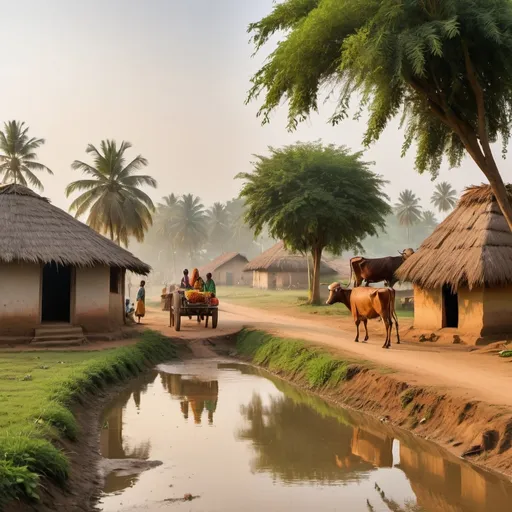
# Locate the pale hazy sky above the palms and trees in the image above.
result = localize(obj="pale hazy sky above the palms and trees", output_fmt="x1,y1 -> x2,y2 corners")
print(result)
0,0 -> 504,214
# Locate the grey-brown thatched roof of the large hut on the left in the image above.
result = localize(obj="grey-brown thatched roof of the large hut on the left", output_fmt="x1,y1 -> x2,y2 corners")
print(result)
0,185 -> 151,275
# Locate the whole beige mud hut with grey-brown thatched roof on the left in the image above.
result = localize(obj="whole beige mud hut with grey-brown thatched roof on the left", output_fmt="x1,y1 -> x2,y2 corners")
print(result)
0,185 -> 151,342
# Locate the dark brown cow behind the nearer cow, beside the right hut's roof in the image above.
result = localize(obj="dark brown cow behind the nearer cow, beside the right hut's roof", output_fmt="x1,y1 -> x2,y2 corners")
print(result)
350,249 -> 414,288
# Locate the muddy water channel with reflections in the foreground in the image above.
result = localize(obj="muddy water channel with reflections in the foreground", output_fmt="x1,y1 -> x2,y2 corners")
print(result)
100,361 -> 512,512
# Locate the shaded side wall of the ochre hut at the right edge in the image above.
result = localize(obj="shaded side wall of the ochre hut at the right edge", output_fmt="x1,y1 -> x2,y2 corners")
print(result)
482,286 -> 512,336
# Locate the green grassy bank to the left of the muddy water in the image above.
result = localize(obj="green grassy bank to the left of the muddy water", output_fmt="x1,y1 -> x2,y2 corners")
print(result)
0,331 -> 175,508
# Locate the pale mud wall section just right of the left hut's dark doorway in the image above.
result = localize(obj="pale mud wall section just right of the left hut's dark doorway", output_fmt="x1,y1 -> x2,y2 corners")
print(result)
73,266 -> 110,332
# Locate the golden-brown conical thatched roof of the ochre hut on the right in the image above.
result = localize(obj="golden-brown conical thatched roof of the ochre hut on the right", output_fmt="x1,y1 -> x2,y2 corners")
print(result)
397,185 -> 512,290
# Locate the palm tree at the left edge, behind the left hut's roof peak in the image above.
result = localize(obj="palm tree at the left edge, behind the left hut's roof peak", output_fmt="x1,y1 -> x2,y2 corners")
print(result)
0,121 -> 53,190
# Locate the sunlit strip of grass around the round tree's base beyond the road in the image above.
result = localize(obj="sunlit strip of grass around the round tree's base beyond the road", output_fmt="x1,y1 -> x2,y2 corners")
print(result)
217,286 -> 414,318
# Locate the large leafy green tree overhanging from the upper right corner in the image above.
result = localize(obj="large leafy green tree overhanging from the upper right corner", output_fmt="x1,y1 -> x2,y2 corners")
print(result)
248,0 -> 512,229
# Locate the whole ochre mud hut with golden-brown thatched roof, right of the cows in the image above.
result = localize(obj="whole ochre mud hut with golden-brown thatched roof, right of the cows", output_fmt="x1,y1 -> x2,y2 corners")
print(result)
397,185 -> 512,342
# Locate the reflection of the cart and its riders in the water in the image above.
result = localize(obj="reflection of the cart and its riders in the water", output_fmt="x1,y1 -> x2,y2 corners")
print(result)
160,373 -> 219,425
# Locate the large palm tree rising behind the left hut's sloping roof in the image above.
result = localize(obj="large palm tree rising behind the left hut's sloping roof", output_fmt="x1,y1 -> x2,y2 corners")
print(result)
66,140 -> 157,247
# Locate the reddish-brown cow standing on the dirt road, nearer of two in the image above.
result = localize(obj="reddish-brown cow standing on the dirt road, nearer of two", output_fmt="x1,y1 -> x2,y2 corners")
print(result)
327,283 -> 400,348
